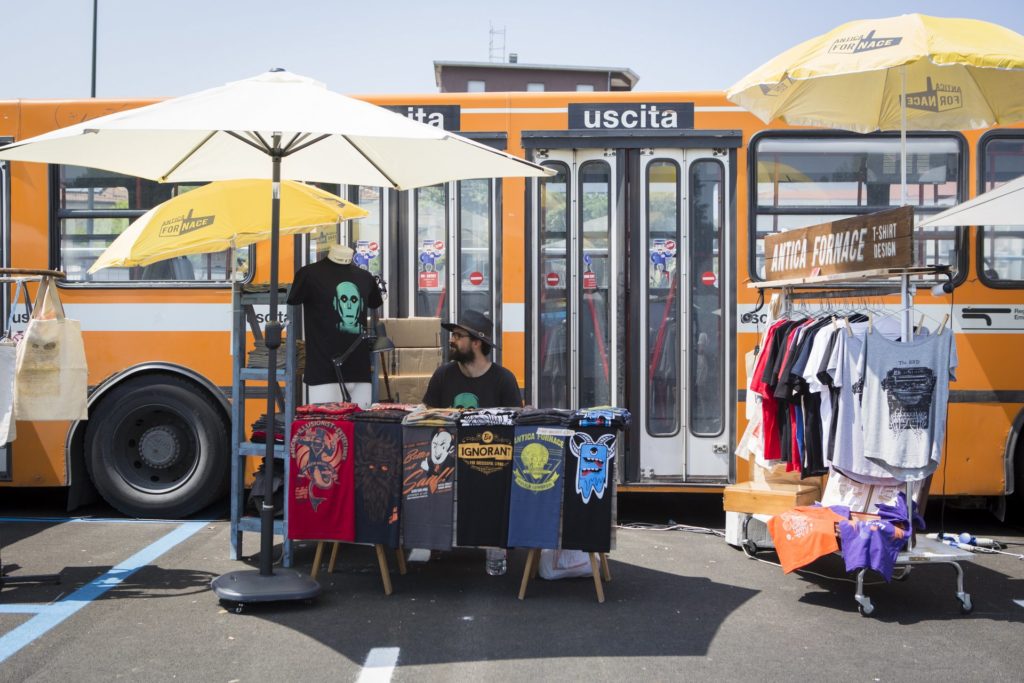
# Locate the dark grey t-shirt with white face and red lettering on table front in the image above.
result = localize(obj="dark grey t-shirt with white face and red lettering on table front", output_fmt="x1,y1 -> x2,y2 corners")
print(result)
401,425 -> 456,550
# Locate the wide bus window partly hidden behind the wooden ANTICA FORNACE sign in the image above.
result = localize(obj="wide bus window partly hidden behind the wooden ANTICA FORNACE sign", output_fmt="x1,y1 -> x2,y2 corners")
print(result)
750,134 -> 965,279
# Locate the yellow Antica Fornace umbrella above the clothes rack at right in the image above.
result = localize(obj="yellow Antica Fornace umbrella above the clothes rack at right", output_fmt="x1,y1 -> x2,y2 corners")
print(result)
726,14 -> 1024,204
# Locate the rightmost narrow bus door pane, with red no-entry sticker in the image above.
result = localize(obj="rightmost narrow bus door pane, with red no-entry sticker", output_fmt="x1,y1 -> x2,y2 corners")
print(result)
688,160 -> 725,436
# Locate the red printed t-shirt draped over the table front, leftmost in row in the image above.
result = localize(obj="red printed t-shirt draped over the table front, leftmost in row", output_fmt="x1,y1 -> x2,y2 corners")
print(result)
288,415 -> 355,542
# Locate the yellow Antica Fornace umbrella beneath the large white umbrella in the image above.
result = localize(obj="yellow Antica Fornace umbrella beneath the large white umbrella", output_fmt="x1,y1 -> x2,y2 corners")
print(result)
89,179 -> 369,273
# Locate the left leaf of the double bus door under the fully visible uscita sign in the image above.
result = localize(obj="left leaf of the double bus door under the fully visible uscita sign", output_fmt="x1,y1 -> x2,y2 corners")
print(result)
527,150 -> 625,408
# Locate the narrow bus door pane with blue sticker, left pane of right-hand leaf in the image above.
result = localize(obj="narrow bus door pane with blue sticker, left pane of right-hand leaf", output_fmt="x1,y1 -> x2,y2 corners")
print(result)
646,161 -> 683,436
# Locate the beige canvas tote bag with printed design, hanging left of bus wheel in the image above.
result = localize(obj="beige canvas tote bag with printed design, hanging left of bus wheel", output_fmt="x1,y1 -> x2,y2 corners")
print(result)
14,278 -> 89,420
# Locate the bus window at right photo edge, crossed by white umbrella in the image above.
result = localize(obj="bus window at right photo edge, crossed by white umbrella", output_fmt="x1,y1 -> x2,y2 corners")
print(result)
978,131 -> 1024,288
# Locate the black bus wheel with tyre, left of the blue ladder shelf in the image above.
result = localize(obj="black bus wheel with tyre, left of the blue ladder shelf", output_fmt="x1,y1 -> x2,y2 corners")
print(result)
85,375 -> 229,518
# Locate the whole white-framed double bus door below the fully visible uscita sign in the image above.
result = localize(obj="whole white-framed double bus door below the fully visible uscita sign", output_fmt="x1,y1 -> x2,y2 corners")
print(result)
527,144 -> 735,484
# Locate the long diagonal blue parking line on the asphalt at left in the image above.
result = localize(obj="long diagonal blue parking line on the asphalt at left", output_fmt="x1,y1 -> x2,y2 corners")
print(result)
0,521 -> 206,663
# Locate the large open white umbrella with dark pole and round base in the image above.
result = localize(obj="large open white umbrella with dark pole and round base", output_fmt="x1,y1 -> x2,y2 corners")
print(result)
0,69 -> 553,603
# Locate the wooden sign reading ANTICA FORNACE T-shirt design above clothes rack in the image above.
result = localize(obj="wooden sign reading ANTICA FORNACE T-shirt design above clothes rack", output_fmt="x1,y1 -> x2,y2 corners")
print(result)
765,206 -> 913,281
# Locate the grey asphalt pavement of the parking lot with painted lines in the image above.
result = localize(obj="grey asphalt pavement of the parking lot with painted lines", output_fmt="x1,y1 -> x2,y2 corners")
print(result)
0,492 -> 1024,682
